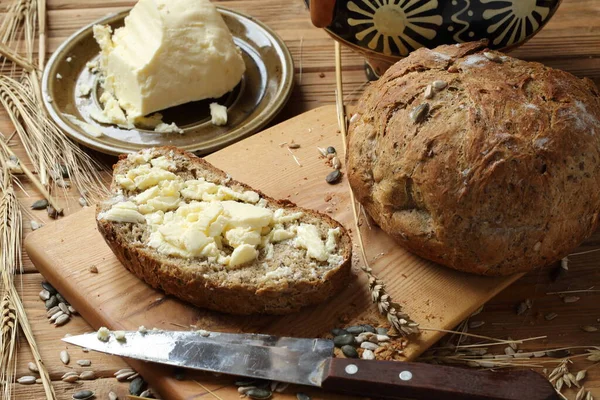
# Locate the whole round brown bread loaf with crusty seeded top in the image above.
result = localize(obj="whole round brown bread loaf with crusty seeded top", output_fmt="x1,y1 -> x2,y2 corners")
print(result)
347,42 -> 600,275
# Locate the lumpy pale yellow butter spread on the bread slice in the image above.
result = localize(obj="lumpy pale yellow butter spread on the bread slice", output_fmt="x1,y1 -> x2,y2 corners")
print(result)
98,152 -> 344,268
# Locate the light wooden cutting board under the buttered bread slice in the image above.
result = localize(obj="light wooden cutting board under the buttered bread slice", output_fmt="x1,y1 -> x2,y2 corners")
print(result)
25,106 -> 519,400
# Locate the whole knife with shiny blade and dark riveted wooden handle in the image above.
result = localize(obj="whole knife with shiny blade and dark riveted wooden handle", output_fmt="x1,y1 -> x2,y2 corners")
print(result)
62,330 -> 559,400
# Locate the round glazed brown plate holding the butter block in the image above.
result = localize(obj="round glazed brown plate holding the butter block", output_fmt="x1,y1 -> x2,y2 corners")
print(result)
42,7 -> 294,154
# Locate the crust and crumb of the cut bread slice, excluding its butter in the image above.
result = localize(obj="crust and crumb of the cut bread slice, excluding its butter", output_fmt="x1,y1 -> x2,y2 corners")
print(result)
96,147 -> 352,314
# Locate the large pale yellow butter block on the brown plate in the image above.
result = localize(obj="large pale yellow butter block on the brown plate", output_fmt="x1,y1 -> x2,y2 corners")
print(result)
94,0 -> 245,120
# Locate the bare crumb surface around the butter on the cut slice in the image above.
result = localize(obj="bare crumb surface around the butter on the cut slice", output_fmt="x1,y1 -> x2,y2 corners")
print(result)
98,148 -> 350,288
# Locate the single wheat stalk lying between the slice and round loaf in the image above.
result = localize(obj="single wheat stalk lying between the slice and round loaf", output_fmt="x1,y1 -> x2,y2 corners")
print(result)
335,41 -> 419,336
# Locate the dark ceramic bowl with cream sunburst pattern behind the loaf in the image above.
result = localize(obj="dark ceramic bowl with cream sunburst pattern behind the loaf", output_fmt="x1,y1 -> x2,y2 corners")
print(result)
305,0 -> 561,75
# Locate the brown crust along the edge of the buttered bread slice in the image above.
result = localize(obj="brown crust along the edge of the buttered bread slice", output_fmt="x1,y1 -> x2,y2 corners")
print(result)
96,147 -> 352,315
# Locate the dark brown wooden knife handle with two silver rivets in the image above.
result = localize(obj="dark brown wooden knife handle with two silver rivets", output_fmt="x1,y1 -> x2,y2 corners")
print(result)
321,358 -> 559,400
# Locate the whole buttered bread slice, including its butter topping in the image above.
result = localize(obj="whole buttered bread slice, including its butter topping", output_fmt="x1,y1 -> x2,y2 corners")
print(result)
97,147 -> 352,314
